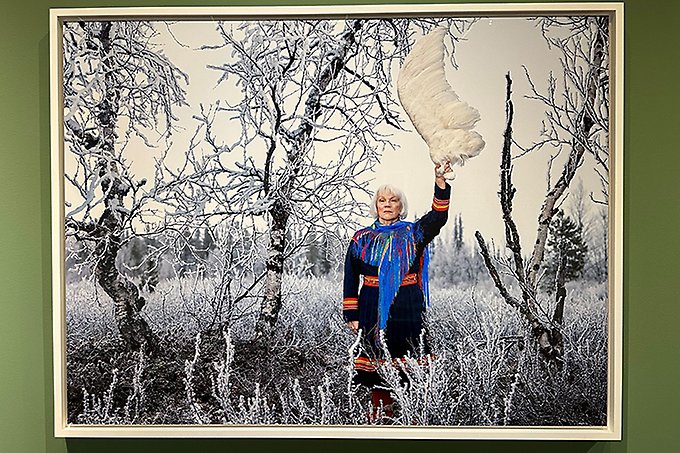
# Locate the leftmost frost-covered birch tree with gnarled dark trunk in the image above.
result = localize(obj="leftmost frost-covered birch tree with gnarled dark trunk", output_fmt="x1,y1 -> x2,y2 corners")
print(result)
63,21 -> 187,349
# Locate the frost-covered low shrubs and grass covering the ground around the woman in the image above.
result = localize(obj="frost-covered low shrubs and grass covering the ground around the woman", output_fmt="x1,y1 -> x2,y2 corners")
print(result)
68,274 -> 607,426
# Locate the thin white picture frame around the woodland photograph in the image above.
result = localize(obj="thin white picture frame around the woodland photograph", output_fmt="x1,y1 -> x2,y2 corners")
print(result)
50,3 -> 624,441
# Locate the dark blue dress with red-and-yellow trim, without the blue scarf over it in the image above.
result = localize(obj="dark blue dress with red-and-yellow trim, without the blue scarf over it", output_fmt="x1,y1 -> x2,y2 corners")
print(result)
343,184 -> 451,387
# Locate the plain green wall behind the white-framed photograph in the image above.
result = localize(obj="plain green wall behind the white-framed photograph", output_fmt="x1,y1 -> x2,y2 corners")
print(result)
0,0 -> 680,453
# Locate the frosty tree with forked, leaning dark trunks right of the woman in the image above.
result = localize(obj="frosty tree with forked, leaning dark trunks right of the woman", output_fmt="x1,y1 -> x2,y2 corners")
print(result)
475,16 -> 609,363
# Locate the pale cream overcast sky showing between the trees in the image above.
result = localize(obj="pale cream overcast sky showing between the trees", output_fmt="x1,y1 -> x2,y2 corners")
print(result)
65,18 -> 599,249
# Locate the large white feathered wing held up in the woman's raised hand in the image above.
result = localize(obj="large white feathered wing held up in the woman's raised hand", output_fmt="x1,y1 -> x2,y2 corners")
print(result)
397,27 -> 485,179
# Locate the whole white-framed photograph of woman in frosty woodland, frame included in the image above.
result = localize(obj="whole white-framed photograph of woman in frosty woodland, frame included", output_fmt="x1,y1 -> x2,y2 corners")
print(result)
50,3 -> 623,440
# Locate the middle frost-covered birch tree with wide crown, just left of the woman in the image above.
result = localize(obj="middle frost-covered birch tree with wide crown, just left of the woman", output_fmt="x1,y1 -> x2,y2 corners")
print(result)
196,18 -> 471,338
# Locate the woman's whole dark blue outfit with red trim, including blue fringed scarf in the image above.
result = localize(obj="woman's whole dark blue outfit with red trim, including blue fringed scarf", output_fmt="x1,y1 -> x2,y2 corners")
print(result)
343,184 -> 451,387
